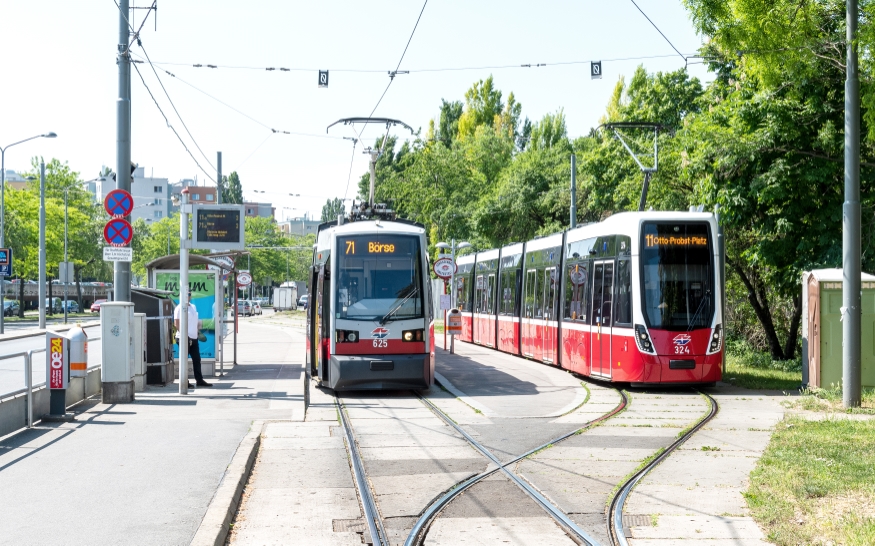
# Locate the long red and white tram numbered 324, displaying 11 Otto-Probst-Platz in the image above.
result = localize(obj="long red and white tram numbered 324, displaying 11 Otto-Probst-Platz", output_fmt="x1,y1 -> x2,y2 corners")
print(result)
455,212 -> 723,384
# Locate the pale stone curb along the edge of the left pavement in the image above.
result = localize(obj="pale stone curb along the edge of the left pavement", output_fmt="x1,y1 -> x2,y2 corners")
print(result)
191,420 -> 265,546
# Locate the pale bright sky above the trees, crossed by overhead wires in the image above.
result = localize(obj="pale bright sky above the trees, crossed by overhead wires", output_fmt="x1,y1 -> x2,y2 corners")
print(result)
0,0 -> 711,220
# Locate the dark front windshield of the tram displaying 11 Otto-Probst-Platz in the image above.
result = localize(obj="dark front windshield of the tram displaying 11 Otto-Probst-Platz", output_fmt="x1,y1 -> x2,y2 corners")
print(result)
641,222 -> 714,331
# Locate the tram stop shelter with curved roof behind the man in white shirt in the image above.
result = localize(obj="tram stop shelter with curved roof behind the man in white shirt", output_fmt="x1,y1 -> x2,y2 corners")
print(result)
146,254 -> 237,377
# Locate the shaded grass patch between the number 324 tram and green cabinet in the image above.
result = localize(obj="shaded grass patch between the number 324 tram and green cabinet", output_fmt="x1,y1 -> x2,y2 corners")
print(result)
723,339 -> 802,391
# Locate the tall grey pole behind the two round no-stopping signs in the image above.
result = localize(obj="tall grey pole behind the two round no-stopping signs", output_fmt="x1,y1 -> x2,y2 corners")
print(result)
113,0 -> 131,301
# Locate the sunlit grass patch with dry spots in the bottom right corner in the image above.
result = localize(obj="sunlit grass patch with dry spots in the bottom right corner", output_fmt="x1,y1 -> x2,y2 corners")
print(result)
745,418 -> 875,546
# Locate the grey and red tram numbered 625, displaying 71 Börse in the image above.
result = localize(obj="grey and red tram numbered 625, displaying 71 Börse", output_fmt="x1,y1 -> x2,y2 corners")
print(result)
307,220 -> 434,390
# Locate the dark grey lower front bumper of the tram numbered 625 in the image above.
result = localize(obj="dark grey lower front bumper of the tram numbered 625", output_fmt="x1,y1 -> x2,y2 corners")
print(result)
327,354 -> 434,391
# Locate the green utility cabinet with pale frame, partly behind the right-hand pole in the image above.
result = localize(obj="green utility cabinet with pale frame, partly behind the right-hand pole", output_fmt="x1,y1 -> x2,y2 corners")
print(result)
802,269 -> 875,387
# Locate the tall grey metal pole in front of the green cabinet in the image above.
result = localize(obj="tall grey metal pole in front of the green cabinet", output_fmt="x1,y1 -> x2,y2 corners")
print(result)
842,0 -> 861,408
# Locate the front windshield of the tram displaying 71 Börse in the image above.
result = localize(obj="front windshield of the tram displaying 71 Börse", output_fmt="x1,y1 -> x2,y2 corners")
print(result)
335,234 -> 424,322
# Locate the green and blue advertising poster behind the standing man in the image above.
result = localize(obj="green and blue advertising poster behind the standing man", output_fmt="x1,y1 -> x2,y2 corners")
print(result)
155,271 -> 221,360
